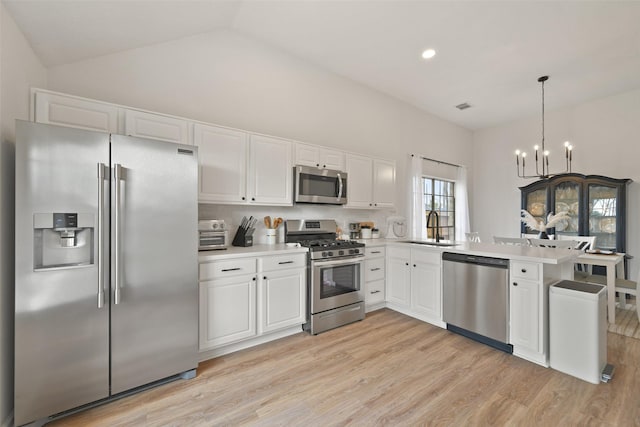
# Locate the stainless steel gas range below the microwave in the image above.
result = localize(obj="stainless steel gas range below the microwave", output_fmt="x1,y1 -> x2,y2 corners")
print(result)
285,220 -> 364,335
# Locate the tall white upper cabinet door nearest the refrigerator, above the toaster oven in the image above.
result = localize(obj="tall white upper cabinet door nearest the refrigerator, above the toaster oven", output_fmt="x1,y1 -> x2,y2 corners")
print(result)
193,124 -> 248,203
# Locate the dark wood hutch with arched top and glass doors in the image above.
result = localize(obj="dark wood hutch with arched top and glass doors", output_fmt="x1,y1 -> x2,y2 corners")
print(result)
520,173 -> 631,253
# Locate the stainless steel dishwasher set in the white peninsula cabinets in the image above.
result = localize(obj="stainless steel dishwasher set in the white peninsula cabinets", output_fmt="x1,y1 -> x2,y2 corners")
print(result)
442,252 -> 513,353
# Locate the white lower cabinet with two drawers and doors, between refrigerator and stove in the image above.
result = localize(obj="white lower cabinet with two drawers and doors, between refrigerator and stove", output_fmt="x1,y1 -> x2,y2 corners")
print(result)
199,253 -> 307,360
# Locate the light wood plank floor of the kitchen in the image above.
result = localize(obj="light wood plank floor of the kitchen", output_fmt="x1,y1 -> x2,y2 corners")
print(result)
51,309 -> 640,426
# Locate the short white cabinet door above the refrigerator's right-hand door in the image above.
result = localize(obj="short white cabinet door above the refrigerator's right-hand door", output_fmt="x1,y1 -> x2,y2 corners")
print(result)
124,110 -> 189,144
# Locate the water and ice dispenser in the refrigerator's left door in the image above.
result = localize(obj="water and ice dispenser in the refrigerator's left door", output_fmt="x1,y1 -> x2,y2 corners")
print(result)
33,213 -> 95,270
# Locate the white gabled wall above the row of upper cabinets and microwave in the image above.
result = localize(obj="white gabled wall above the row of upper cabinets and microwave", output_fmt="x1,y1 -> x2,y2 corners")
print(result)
48,31 -> 471,226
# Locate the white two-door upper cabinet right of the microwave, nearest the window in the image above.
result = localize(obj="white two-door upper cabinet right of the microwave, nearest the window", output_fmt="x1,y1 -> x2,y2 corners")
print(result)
346,154 -> 396,208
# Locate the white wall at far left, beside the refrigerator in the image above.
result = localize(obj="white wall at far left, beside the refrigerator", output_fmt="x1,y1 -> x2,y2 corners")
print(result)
0,5 -> 47,426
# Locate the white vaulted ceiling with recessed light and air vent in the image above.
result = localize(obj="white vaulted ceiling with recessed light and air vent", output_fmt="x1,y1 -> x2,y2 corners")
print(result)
3,0 -> 640,129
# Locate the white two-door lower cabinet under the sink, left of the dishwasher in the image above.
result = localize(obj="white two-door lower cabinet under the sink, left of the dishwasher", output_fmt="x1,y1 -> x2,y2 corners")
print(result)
387,246 -> 445,327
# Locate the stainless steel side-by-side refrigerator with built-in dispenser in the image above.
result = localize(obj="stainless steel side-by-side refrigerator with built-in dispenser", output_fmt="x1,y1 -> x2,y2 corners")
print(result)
14,121 -> 198,425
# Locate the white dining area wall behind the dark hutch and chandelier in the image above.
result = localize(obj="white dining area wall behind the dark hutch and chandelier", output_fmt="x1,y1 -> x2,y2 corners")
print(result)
472,90 -> 640,278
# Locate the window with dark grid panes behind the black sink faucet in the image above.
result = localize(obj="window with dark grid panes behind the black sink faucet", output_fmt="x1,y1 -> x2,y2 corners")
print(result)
423,177 -> 456,240
